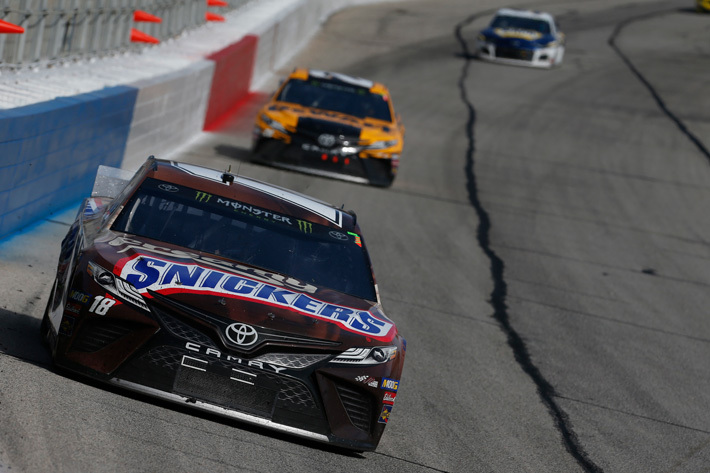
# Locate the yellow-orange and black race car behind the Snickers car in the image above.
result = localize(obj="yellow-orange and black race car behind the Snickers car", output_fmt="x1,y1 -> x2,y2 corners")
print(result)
252,69 -> 404,187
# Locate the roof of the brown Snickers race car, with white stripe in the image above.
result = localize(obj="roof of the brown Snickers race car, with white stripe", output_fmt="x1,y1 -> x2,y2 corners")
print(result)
146,158 -> 359,233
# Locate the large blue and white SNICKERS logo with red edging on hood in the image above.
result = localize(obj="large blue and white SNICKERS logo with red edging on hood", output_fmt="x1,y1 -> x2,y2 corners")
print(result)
115,251 -> 394,341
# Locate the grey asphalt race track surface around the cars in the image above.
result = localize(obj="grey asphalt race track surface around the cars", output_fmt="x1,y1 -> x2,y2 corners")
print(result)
0,0 -> 710,472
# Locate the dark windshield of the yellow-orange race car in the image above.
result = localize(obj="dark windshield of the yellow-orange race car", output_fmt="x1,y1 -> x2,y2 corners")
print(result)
276,79 -> 392,122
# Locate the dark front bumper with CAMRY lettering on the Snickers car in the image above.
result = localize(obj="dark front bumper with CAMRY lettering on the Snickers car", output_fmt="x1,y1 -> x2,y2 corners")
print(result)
53,292 -> 399,451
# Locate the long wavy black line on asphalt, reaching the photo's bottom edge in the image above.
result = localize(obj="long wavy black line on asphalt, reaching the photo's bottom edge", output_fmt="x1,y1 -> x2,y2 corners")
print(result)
455,9 -> 603,473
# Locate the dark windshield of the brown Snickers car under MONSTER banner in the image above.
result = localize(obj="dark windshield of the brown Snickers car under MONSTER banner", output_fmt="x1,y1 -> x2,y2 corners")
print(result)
112,178 -> 377,301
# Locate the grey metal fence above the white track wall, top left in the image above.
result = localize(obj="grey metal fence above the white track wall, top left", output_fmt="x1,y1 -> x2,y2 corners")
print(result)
0,0 -> 251,70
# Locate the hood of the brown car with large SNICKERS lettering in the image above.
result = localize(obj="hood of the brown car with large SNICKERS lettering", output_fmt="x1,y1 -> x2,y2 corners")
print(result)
86,231 -> 397,346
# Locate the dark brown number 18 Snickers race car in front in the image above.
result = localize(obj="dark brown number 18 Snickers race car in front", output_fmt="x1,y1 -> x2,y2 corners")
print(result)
41,157 -> 406,451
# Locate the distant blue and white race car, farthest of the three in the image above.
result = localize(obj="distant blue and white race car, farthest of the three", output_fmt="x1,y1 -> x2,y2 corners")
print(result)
475,8 -> 565,68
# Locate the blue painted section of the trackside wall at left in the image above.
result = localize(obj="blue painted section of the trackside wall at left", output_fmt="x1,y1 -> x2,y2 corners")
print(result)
0,86 -> 138,238
